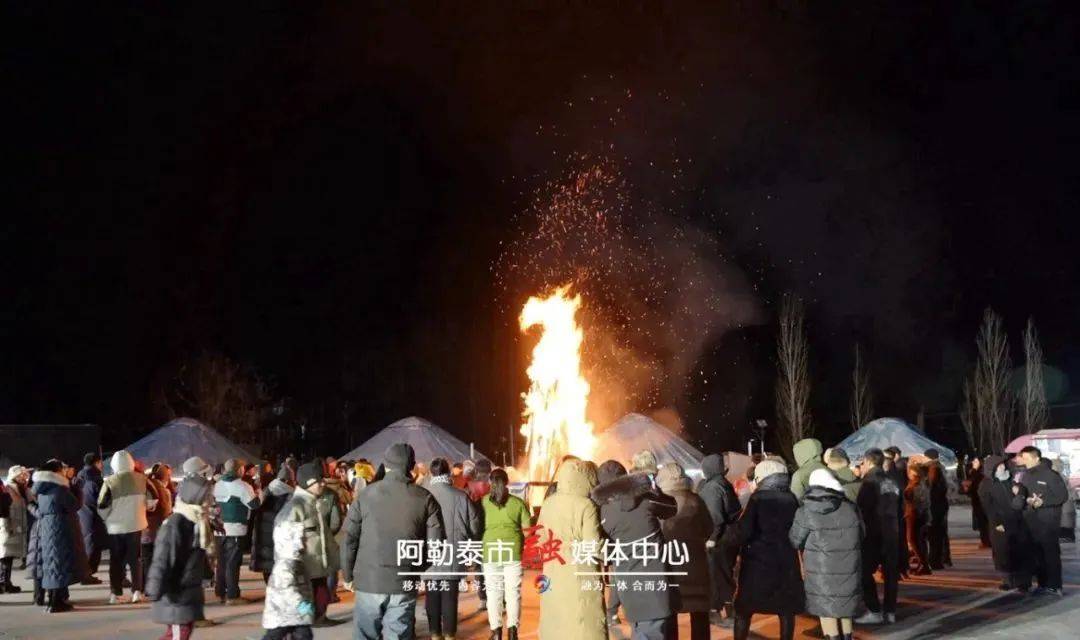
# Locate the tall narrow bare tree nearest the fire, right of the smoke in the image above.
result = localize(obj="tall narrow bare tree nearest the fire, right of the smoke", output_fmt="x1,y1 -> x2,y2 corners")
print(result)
777,294 -> 813,454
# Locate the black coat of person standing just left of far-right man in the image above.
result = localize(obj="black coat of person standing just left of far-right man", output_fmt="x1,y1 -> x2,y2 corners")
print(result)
978,459 -> 1030,573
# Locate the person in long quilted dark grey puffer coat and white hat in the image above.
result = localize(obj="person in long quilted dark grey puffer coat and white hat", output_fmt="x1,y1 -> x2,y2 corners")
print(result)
789,469 -> 863,640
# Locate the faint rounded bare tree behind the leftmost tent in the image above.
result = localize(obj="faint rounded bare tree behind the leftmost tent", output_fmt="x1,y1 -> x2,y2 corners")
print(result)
160,352 -> 271,442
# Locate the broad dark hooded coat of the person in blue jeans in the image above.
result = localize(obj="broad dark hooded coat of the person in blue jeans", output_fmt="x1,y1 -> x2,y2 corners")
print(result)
341,471 -> 445,594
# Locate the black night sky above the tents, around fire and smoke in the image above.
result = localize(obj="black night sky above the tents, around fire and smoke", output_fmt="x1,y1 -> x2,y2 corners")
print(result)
8,0 -> 1080,452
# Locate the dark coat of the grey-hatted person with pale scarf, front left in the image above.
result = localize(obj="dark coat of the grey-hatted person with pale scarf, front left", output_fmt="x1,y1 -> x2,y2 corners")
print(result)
146,513 -> 206,625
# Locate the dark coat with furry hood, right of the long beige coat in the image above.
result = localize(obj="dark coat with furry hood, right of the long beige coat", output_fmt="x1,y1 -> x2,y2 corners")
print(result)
592,463 -> 679,622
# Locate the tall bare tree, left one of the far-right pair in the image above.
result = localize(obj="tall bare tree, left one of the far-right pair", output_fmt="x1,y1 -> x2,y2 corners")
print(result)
971,309 -> 1013,453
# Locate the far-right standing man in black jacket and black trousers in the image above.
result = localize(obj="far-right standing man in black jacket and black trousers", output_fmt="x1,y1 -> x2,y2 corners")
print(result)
1016,447 -> 1068,596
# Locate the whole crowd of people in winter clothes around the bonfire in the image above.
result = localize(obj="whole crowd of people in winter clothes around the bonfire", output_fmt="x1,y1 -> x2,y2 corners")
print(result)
0,438 -> 1075,640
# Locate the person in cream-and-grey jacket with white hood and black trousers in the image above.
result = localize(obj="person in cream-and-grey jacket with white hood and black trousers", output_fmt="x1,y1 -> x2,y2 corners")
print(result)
97,451 -> 157,604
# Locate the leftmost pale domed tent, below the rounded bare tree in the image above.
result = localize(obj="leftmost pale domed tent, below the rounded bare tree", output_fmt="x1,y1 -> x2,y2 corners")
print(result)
120,418 -> 258,475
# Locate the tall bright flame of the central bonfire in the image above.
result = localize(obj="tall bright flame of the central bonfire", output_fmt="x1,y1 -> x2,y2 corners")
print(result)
519,286 -> 596,480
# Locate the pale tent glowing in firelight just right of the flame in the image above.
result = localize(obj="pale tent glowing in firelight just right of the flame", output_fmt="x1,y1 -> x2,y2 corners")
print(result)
593,413 -> 705,471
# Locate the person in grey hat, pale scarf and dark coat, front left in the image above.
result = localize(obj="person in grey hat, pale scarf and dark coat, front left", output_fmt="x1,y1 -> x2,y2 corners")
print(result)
146,474 -> 214,640
